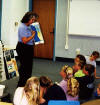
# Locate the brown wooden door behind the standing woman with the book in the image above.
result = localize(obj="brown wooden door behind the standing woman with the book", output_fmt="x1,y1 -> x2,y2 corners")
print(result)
32,0 -> 55,59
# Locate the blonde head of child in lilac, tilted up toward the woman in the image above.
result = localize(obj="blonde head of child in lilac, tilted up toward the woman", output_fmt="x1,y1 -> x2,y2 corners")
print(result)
60,65 -> 73,79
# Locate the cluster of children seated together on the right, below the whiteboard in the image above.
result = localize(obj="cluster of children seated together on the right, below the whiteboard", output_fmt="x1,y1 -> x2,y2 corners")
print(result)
59,51 -> 100,102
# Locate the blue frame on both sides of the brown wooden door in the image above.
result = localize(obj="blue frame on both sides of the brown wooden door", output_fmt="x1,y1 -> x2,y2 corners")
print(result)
29,0 -> 57,61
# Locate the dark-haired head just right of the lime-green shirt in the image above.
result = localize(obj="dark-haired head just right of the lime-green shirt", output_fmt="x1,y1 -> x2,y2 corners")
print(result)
83,64 -> 95,76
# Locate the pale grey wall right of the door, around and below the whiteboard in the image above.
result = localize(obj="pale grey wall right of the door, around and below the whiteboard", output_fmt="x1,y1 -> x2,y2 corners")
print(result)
55,0 -> 100,58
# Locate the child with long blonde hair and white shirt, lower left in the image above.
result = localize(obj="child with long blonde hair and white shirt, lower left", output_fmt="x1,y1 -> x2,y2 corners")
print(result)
13,77 -> 40,105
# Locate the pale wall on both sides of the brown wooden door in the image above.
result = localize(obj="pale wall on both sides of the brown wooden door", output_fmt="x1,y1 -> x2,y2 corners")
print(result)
1,0 -> 100,58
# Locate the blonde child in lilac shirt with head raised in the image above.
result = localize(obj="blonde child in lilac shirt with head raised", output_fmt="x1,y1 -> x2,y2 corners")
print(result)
59,65 -> 79,101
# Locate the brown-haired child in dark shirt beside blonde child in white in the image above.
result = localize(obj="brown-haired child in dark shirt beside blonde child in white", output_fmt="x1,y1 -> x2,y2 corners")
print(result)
39,76 -> 66,105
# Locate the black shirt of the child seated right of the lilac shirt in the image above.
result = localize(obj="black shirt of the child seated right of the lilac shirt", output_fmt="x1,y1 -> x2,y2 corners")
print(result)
75,76 -> 94,99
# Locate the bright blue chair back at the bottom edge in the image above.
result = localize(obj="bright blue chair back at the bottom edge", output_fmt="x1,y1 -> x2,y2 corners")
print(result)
48,100 -> 80,105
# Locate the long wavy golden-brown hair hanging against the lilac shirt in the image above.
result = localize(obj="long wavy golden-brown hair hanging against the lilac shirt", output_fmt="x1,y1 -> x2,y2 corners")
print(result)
67,77 -> 79,97
